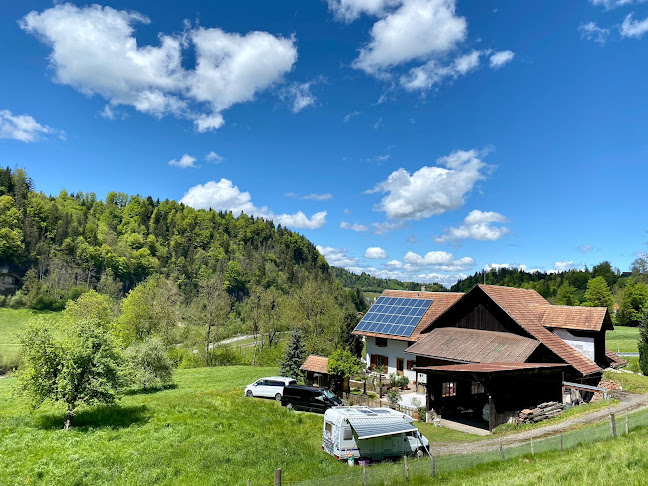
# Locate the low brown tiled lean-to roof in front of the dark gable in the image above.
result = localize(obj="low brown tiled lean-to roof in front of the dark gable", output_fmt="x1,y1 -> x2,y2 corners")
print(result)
405,327 -> 540,363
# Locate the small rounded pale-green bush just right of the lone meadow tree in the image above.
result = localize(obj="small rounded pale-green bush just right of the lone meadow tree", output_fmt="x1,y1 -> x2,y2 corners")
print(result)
124,338 -> 173,390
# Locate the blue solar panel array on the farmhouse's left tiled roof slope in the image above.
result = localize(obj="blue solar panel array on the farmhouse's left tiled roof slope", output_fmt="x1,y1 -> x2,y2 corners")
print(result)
355,297 -> 432,337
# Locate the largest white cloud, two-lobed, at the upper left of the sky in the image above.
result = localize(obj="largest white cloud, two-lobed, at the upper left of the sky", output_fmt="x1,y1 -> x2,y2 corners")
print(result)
20,3 -> 297,132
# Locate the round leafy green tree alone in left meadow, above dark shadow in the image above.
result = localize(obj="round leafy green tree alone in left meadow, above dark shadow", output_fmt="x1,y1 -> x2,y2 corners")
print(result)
18,320 -> 119,429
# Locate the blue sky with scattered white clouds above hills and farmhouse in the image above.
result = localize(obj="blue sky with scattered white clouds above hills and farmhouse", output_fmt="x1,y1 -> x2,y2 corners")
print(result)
0,0 -> 648,284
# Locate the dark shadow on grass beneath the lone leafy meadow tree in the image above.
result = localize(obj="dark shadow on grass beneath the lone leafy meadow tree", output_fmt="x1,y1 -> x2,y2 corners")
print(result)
36,405 -> 149,432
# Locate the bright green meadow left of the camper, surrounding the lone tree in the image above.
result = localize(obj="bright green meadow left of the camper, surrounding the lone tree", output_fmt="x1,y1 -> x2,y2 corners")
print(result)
0,367 -> 476,485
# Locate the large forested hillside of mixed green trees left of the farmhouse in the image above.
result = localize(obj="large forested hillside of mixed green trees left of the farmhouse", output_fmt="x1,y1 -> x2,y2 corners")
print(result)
0,168 -> 365,362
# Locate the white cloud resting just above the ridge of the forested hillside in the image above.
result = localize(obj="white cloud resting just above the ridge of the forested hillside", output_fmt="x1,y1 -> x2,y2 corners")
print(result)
180,178 -> 327,229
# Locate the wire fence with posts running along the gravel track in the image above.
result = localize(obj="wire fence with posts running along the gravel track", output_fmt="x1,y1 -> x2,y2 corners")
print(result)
248,411 -> 648,486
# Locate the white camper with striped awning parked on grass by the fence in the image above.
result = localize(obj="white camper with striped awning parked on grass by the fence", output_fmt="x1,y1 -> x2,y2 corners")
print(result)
322,407 -> 429,460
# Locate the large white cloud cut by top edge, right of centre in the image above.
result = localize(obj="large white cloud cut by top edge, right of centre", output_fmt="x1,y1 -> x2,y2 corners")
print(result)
353,0 -> 467,74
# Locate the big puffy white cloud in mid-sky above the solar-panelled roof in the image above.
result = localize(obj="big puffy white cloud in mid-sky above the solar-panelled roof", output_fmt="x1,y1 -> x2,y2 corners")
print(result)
367,150 -> 487,220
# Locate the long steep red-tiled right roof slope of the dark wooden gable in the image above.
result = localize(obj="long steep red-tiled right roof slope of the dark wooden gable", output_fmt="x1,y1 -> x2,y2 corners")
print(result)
478,285 -> 601,375
